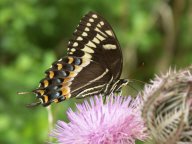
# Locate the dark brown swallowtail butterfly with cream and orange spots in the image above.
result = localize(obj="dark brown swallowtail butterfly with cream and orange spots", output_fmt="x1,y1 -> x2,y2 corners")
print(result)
24,12 -> 128,107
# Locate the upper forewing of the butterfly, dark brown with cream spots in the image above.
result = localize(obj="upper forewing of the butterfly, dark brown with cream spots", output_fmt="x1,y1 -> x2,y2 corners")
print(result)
68,12 -> 123,79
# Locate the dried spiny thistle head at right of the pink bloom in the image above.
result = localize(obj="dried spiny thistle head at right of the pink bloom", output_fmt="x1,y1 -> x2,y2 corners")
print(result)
140,65 -> 192,144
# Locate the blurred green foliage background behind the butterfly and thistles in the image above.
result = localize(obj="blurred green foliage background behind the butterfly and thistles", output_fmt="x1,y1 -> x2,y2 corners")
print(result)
0,0 -> 192,144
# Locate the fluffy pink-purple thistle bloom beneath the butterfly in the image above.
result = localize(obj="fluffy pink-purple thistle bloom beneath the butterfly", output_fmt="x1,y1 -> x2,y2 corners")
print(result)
51,96 -> 147,144
